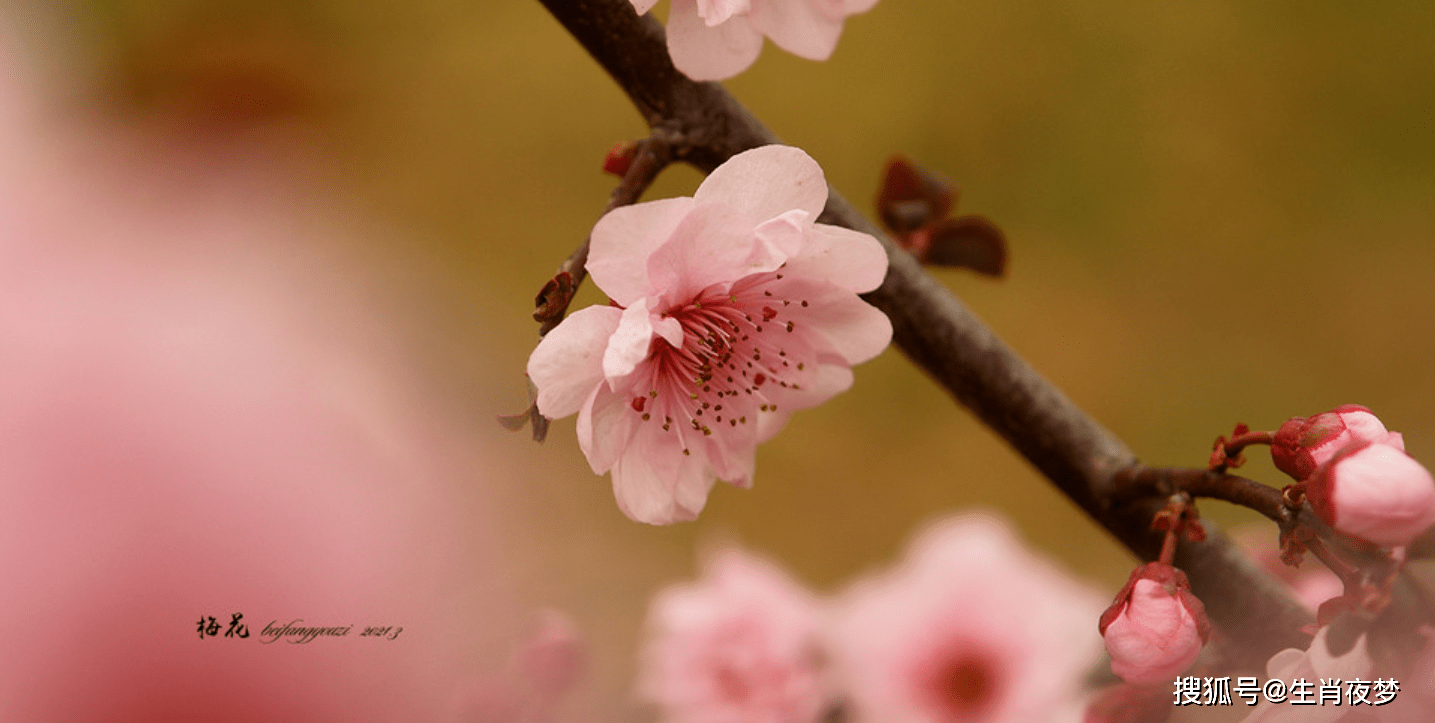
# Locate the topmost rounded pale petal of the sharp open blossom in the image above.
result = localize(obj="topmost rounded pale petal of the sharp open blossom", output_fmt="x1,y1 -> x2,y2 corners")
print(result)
693,145 -> 827,228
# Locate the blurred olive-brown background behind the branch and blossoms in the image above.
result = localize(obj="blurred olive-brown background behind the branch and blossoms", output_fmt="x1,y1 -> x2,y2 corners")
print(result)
0,0 -> 1435,720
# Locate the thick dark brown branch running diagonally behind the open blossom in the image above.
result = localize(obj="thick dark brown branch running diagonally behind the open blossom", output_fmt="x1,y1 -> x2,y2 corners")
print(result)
541,0 -> 1312,667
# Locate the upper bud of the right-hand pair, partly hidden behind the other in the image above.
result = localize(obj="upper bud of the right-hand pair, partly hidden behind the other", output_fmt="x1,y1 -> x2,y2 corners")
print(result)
1270,405 -> 1405,481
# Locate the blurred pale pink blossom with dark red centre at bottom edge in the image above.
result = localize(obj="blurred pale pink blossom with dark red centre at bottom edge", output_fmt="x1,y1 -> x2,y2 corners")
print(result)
832,515 -> 1102,723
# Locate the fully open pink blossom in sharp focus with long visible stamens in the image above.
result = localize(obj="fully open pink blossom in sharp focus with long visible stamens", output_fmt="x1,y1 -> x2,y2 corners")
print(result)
528,146 -> 891,524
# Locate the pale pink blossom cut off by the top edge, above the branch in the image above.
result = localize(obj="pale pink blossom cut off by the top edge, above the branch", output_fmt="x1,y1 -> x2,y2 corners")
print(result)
633,0 -> 877,80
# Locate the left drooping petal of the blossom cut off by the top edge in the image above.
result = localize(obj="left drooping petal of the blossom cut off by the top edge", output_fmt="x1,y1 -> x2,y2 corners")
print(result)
667,0 -> 762,80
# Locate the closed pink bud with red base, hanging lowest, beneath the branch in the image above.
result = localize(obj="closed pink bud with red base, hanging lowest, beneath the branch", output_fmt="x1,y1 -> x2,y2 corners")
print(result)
1101,562 -> 1211,683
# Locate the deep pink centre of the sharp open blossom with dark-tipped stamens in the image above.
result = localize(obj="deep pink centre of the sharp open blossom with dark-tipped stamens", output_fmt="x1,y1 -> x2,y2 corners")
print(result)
631,270 -> 815,453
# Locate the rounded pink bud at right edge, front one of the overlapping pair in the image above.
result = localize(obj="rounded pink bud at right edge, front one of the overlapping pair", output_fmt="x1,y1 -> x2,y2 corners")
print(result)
1306,442 -> 1435,547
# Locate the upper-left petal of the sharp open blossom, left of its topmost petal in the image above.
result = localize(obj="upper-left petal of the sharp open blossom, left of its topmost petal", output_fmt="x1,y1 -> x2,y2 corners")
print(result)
587,197 -> 693,306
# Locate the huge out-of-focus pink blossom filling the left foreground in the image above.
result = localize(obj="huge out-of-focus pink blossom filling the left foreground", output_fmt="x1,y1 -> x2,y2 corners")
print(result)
0,35 -> 516,723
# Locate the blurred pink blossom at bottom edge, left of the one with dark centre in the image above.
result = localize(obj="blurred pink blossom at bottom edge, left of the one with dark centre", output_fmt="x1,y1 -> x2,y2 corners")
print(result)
639,549 -> 828,723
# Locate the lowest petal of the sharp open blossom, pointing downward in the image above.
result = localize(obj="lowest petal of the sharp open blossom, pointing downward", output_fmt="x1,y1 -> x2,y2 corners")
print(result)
613,426 -> 715,525
